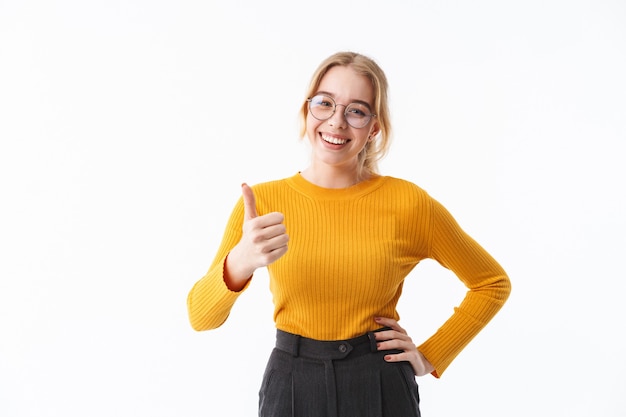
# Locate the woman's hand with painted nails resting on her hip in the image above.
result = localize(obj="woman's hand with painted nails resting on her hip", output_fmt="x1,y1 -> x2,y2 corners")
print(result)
374,317 -> 435,376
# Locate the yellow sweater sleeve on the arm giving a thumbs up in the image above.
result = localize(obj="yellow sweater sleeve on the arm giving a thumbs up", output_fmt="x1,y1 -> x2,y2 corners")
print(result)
187,198 -> 250,331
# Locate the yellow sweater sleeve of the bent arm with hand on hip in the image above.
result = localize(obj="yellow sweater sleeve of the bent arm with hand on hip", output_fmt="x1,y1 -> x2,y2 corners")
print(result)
418,200 -> 511,378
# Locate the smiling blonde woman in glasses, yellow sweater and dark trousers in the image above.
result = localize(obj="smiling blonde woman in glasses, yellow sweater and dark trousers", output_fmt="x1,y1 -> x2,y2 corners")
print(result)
187,52 -> 511,417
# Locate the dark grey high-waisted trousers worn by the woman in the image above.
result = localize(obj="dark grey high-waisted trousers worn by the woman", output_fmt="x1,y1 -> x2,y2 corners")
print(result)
259,329 -> 420,417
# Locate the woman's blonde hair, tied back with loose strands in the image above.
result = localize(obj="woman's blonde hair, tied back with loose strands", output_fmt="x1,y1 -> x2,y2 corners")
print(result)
300,52 -> 391,177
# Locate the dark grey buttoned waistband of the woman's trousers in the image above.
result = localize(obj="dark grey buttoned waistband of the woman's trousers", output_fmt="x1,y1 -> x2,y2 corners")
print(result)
276,327 -> 389,360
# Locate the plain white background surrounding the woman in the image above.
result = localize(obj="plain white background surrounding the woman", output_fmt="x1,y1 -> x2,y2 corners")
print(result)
0,0 -> 626,417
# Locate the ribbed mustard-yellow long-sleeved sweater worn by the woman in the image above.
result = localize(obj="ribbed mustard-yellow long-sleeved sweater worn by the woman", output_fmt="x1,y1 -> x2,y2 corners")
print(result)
187,174 -> 511,377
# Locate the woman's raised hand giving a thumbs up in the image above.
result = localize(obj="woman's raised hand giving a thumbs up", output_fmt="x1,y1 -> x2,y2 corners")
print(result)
224,183 -> 289,291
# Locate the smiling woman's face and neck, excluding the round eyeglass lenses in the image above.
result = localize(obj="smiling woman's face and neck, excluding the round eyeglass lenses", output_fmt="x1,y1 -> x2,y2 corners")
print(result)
306,66 -> 379,170
